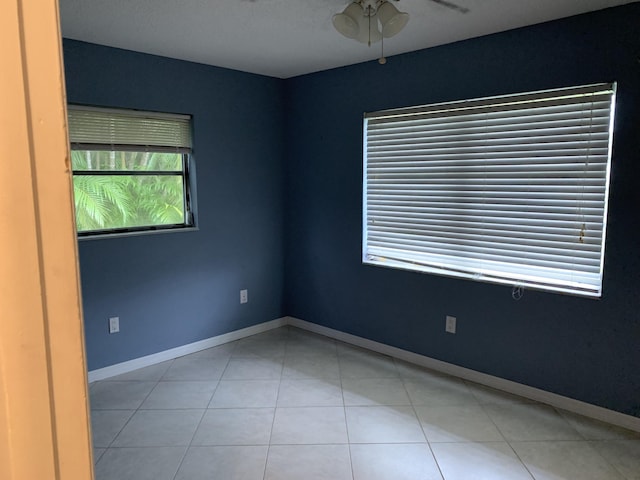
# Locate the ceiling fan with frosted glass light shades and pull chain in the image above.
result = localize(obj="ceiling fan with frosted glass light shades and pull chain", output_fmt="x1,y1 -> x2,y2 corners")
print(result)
332,0 -> 469,54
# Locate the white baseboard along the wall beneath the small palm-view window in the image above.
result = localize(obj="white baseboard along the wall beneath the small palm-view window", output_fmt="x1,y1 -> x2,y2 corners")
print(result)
89,317 -> 287,382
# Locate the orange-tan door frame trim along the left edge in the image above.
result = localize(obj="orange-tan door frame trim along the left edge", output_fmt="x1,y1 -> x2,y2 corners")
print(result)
0,0 -> 93,480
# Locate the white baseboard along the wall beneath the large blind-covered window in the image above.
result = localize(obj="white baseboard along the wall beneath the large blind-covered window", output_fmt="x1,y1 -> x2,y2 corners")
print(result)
284,317 -> 640,432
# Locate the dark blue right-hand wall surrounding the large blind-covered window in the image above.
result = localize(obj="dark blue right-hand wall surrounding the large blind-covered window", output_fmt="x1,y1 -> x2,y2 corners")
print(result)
285,3 -> 640,416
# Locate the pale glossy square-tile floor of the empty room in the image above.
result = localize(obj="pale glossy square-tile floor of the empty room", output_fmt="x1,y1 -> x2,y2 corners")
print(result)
90,327 -> 640,480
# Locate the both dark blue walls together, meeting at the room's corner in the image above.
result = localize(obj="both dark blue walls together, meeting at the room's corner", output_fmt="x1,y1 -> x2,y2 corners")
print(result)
64,3 -> 640,416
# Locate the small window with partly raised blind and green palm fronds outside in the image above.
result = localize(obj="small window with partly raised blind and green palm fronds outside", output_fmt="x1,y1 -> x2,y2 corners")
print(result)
69,106 -> 193,237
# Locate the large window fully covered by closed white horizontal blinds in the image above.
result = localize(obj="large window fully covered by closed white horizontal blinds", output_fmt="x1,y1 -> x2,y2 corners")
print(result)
363,84 -> 615,297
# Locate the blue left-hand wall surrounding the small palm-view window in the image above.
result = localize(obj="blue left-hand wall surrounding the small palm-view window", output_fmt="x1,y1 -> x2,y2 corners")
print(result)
64,40 -> 284,370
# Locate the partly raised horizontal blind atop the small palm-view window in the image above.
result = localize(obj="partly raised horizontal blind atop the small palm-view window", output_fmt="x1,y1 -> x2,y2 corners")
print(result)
68,106 -> 192,152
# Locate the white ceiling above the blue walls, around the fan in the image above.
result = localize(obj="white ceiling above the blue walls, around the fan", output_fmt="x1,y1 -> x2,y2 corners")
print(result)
60,0 -> 635,78
